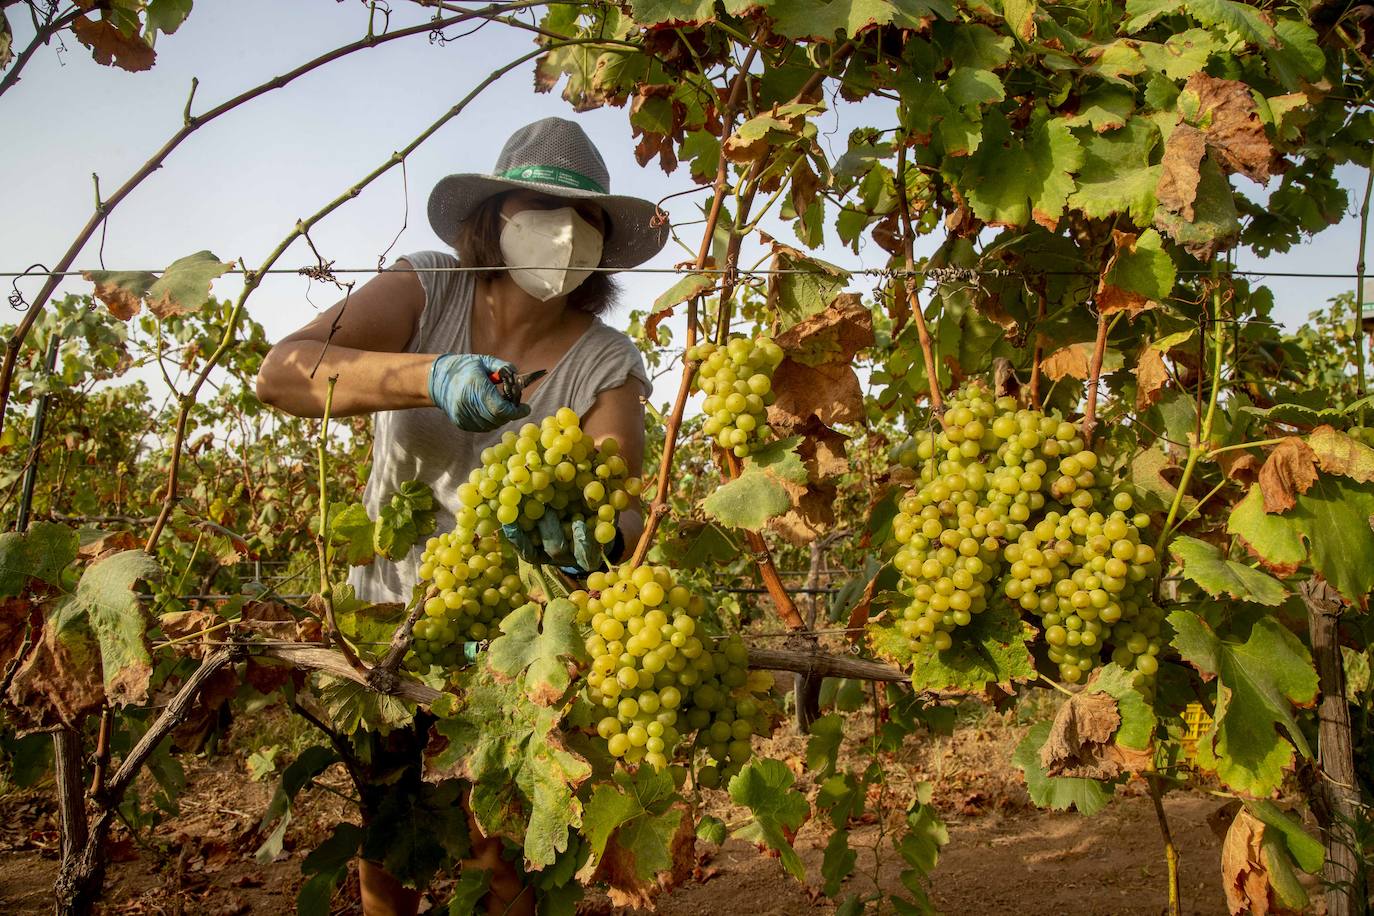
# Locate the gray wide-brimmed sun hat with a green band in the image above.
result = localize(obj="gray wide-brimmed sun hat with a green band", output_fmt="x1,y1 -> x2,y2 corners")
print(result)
429,118 -> 668,268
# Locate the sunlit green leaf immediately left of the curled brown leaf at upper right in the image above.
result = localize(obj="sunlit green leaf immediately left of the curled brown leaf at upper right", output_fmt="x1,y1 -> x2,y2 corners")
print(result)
1069,117 -> 1160,225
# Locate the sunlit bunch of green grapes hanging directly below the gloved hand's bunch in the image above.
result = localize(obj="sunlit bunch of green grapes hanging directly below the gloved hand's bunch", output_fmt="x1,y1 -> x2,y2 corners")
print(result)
569,566 -> 710,769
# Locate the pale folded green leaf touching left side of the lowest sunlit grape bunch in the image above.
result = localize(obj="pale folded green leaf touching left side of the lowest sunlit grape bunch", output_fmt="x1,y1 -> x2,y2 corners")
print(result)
486,597 -> 589,706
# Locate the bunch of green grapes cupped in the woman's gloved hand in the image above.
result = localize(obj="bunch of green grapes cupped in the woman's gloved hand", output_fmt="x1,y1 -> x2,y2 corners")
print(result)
456,407 -> 640,547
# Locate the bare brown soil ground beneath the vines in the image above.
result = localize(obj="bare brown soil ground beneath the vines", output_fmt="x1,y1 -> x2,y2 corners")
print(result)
0,713 -> 1227,916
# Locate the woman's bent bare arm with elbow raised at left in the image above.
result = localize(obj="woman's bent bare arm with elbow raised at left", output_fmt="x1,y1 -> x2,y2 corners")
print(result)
257,260 -> 434,416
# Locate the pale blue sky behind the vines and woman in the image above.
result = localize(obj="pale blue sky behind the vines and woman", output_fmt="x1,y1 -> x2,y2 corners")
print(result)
0,0 -> 1363,401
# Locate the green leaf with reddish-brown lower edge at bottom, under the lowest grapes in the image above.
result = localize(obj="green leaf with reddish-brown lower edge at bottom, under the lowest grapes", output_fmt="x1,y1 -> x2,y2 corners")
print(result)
580,766 -> 692,906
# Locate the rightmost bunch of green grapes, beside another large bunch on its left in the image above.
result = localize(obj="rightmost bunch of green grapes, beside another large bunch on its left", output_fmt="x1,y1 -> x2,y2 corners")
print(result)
1003,490 -> 1161,687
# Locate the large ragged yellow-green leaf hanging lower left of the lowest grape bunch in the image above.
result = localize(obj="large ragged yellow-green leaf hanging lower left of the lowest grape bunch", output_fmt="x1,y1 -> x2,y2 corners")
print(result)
426,666 -> 592,869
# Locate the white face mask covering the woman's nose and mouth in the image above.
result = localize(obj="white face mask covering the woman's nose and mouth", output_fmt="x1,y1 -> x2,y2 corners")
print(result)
502,207 -> 602,302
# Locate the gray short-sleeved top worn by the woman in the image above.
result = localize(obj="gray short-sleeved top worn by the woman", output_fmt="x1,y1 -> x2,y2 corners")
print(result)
349,251 -> 651,602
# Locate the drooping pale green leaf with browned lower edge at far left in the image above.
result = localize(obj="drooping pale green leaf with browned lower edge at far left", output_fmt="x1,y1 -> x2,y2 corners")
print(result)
55,551 -> 162,705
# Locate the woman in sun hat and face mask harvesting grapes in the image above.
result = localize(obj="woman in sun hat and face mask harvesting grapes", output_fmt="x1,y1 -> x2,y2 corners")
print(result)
257,118 -> 668,916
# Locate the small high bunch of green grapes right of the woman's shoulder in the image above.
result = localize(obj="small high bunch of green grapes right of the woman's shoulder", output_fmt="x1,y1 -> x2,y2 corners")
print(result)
687,336 -> 782,457
